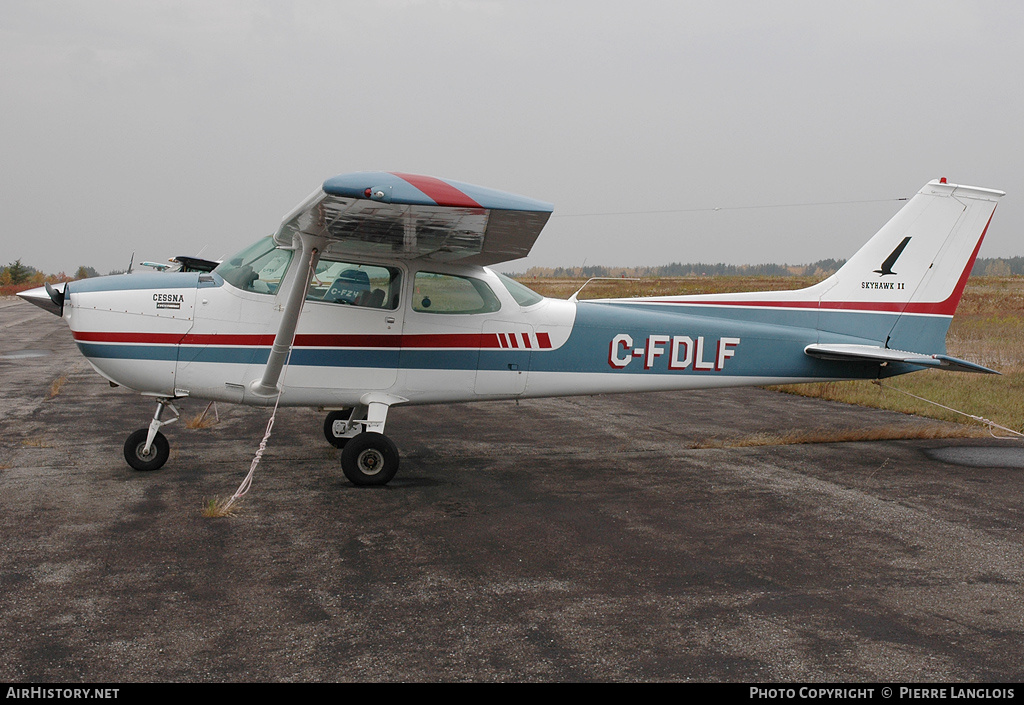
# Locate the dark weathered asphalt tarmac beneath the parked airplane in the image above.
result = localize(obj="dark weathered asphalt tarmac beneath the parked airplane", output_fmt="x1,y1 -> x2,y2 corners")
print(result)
0,298 -> 1024,683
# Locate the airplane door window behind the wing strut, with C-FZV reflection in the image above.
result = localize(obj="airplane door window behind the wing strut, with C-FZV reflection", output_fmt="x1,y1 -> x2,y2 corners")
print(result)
306,258 -> 401,309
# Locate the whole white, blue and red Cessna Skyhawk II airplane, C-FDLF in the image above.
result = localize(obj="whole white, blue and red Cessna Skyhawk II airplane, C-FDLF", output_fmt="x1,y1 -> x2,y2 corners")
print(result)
20,172 -> 1004,485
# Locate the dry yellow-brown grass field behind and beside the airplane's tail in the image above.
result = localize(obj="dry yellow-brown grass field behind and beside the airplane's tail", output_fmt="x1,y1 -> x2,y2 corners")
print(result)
521,277 -> 1024,434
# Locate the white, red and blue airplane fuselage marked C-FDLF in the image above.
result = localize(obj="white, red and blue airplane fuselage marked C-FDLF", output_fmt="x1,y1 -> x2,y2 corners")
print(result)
63,240 -> 914,409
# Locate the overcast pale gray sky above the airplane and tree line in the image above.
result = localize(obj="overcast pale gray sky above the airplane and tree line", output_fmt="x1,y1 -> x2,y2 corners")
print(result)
0,0 -> 1024,273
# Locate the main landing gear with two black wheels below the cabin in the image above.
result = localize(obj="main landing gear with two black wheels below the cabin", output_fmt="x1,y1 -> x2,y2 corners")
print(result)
324,401 -> 398,487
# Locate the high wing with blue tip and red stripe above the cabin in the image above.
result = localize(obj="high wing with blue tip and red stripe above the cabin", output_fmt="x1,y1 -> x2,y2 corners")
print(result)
274,171 -> 553,265
